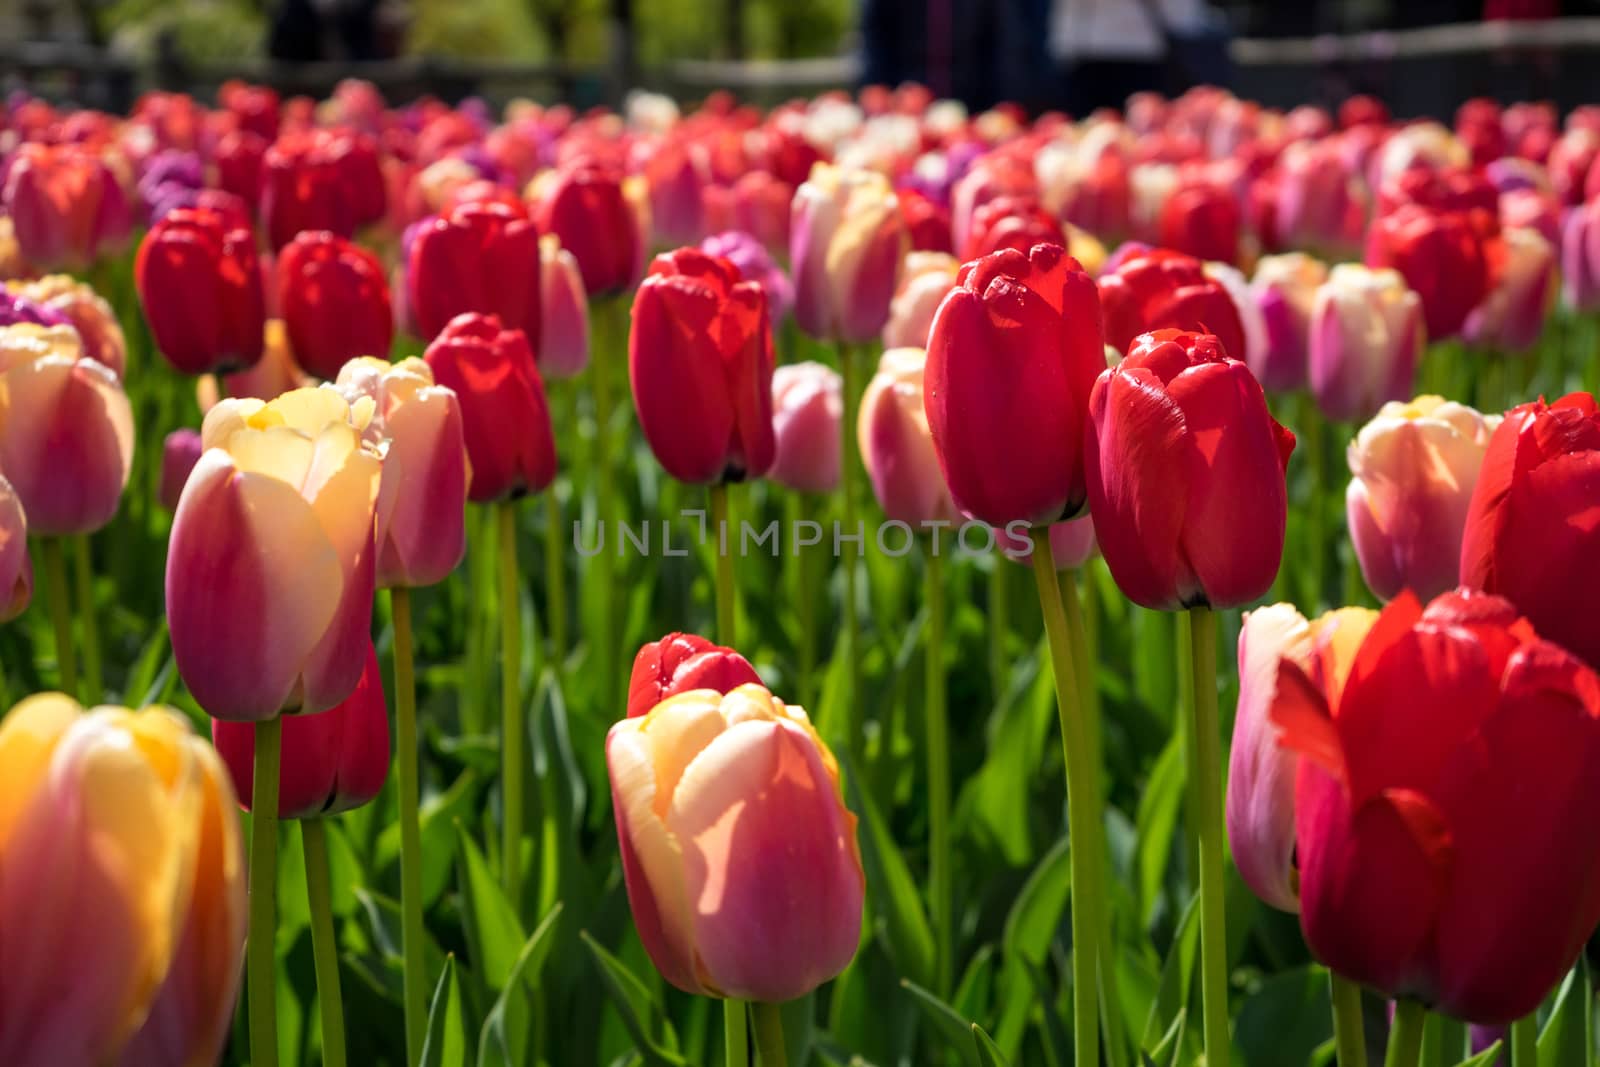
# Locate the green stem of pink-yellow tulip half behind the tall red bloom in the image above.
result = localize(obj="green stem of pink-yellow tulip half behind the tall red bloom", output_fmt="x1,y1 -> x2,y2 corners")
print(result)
928,530 -> 955,998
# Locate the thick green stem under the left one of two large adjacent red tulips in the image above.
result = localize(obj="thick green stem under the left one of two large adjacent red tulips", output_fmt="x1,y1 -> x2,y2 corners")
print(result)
1032,526 -> 1107,1064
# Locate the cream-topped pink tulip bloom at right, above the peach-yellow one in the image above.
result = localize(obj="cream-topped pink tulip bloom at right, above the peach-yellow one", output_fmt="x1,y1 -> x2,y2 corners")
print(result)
1310,262 -> 1424,419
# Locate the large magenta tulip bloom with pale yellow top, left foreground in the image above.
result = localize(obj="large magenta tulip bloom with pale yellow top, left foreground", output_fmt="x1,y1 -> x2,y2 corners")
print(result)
166,389 -> 382,721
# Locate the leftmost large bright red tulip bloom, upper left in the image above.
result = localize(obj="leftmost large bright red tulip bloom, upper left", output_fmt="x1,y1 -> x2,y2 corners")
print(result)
133,208 -> 266,374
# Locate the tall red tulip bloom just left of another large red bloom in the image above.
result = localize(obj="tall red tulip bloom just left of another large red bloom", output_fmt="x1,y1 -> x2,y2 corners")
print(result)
923,245 -> 1106,526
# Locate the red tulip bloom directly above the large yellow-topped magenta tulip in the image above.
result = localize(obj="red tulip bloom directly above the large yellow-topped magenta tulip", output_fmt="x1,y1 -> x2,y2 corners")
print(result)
277,230 -> 395,381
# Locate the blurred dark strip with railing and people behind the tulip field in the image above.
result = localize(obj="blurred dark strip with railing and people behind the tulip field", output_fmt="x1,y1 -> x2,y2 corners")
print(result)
9,0 -> 1600,117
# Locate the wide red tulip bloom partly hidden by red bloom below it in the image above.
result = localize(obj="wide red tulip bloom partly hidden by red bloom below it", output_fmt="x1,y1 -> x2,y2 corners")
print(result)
406,203 -> 544,341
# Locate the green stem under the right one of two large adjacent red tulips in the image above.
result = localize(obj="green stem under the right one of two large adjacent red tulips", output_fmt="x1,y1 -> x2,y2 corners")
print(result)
1189,608 -> 1230,1067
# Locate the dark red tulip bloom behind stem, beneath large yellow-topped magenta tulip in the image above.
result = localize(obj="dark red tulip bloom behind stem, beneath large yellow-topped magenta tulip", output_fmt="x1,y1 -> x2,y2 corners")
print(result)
211,643 -> 389,819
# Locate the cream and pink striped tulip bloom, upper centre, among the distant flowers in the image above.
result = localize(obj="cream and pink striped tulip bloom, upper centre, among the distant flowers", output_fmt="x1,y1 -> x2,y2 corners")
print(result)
789,163 -> 910,344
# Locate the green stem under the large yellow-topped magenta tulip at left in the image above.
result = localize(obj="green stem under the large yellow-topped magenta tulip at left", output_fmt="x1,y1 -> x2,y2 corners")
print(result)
245,715 -> 283,1067
